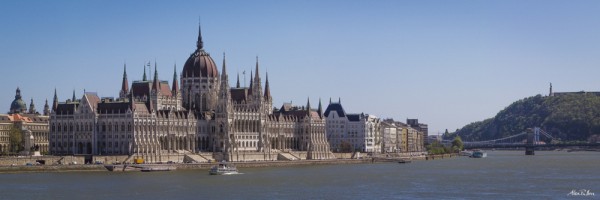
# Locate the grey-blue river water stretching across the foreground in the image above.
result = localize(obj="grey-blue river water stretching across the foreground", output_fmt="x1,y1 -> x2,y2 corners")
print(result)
0,151 -> 600,199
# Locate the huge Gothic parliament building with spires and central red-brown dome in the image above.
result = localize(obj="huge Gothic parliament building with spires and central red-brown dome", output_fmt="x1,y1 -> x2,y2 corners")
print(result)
49,25 -> 334,163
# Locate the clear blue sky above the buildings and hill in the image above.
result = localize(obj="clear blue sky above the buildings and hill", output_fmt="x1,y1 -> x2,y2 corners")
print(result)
0,0 -> 600,134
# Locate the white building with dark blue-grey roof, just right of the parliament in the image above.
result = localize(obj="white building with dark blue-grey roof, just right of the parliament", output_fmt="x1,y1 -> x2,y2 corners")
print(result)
325,100 -> 382,152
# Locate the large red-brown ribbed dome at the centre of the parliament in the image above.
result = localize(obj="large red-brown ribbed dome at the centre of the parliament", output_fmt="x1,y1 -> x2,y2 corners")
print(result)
181,25 -> 219,78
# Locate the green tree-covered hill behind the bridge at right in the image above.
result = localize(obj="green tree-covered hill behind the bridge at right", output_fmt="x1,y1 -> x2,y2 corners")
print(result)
445,94 -> 600,141
